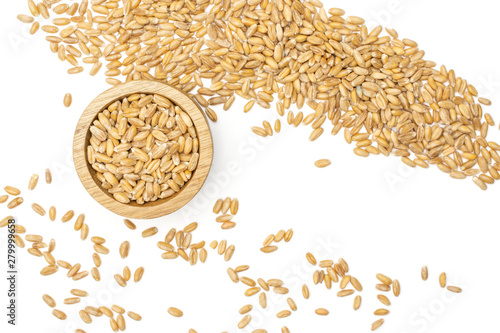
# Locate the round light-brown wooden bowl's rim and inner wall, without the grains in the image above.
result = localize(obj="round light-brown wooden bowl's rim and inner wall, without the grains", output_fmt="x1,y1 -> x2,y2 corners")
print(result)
73,80 -> 213,219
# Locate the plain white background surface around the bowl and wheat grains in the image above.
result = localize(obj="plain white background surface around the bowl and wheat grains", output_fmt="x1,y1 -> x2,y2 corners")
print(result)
0,0 -> 500,333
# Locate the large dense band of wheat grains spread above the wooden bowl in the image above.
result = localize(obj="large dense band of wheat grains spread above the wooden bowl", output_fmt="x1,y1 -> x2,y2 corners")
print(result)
18,0 -> 500,188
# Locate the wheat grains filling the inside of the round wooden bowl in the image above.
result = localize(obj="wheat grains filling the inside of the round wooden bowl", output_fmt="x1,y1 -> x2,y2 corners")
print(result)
87,94 -> 199,204
